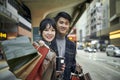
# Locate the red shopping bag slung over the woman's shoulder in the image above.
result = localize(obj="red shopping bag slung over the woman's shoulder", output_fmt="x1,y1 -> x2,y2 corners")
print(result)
26,46 -> 49,80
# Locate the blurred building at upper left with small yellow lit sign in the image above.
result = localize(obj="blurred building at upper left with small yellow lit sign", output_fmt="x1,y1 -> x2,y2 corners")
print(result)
0,0 -> 32,41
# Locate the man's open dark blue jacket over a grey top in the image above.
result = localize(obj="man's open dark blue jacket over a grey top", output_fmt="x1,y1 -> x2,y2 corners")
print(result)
50,37 -> 76,80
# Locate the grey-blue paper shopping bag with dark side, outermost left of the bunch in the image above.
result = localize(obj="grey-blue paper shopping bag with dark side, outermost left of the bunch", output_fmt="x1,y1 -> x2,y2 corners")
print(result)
1,36 -> 38,72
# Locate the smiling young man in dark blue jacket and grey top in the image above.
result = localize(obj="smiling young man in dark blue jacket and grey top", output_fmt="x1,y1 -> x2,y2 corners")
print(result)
50,12 -> 76,80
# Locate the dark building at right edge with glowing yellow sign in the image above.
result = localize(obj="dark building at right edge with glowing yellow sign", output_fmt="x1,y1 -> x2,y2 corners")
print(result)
109,0 -> 120,46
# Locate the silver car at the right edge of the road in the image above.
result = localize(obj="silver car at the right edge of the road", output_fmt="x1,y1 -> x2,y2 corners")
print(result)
106,45 -> 120,56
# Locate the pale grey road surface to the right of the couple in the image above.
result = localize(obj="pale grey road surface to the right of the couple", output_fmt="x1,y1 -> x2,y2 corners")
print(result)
76,50 -> 120,80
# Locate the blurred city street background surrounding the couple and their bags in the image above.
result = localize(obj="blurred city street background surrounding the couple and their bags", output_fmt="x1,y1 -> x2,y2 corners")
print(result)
0,0 -> 120,80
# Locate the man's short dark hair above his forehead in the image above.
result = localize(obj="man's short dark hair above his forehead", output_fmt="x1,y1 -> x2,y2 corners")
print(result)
54,12 -> 72,23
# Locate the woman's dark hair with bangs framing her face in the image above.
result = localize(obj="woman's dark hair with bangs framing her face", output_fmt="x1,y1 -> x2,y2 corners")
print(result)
39,18 -> 56,36
